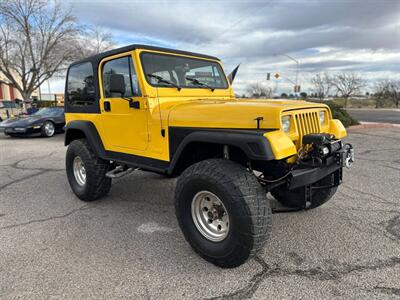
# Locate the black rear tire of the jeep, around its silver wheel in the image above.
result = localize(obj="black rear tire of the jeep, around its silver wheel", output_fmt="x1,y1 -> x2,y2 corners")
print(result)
65,139 -> 111,201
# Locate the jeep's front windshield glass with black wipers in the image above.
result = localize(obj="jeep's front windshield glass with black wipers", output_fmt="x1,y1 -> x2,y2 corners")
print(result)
141,52 -> 228,89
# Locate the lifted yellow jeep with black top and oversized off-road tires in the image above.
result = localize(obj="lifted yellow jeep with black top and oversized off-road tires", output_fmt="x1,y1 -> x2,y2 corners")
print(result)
65,45 -> 354,267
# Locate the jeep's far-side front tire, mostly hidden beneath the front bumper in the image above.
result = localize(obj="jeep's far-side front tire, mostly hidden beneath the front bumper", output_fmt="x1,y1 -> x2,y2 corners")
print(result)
271,175 -> 337,209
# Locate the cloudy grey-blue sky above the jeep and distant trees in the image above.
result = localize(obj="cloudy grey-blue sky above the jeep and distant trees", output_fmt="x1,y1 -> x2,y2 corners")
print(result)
47,0 -> 400,94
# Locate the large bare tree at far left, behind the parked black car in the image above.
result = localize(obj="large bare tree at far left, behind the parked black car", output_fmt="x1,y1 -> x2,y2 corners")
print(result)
0,0 -> 112,100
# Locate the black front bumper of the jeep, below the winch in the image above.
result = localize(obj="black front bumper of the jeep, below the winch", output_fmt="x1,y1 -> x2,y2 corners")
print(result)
286,144 -> 354,190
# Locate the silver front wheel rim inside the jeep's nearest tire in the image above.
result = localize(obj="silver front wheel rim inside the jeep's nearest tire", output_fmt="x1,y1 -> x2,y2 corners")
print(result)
191,191 -> 230,242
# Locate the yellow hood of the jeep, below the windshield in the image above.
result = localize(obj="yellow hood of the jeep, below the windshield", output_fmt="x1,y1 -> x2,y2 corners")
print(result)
168,99 -> 327,129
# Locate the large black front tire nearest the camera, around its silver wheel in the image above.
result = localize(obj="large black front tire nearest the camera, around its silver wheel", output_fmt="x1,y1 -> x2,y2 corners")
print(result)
175,159 -> 271,268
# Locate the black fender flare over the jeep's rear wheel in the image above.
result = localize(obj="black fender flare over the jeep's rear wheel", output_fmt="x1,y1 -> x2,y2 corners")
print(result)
64,120 -> 106,158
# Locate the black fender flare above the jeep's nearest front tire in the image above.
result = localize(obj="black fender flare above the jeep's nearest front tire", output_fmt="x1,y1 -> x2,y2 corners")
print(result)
168,129 -> 275,174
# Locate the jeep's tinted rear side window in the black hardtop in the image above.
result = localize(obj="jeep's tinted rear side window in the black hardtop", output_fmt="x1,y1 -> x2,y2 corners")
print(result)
67,62 -> 96,105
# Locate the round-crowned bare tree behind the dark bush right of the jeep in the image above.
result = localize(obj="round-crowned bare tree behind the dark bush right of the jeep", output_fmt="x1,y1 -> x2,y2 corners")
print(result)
329,73 -> 365,107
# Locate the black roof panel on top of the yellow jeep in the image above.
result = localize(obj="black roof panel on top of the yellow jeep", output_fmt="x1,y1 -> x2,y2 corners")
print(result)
71,44 -> 220,65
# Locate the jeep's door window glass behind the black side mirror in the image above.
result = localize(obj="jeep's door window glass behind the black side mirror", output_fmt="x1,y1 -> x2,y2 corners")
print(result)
103,56 -> 140,98
